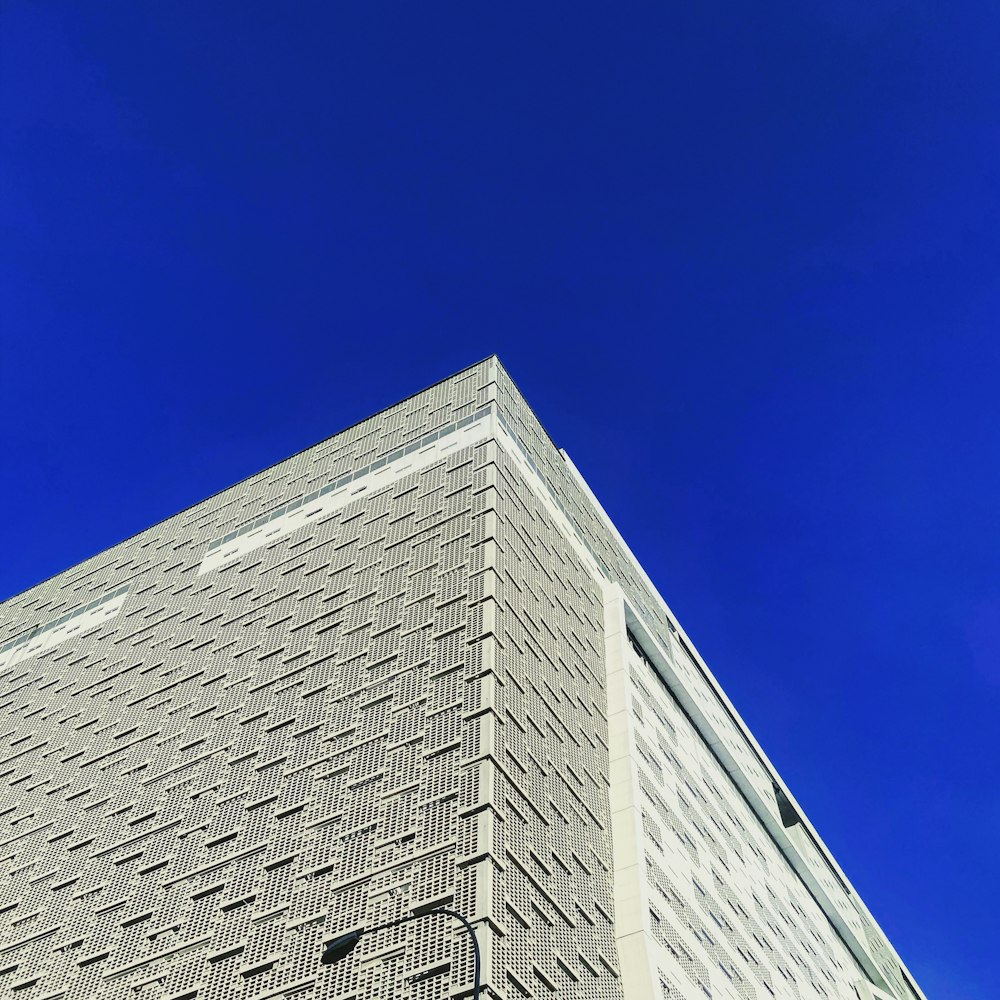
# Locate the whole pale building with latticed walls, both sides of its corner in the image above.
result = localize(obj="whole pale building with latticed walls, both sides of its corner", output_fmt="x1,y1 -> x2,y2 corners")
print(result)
0,358 -> 923,1000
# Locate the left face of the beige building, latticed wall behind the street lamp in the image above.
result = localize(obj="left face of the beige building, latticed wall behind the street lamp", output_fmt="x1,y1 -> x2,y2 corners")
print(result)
0,364 -> 556,1000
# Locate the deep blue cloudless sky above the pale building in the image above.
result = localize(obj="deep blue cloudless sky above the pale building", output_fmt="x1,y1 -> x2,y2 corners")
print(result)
0,0 -> 1000,1000
